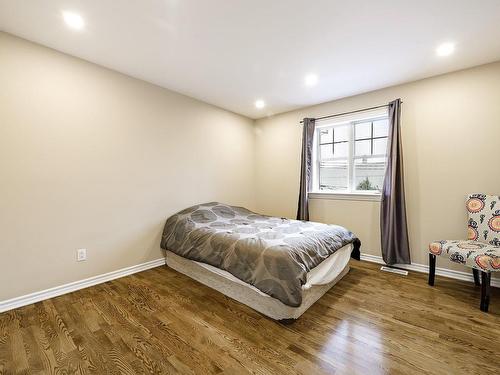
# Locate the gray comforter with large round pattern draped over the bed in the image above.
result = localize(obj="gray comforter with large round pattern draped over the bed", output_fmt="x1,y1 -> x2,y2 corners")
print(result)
161,202 -> 359,307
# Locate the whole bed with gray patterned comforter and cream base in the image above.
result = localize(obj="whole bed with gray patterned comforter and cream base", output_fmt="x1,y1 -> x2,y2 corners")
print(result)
161,202 -> 361,322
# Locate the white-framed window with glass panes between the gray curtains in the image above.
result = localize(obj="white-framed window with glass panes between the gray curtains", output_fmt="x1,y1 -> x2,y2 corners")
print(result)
313,111 -> 389,193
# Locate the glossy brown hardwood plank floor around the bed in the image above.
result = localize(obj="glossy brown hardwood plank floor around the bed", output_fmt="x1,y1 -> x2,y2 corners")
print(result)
0,261 -> 500,374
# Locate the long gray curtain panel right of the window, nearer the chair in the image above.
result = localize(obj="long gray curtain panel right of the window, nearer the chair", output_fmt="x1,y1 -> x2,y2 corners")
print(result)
380,99 -> 410,264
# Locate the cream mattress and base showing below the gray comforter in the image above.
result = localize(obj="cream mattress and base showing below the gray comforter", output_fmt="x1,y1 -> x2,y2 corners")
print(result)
166,244 -> 352,320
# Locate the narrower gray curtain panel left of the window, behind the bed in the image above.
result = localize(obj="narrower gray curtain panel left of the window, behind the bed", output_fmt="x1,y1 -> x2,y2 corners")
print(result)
297,118 -> 315,220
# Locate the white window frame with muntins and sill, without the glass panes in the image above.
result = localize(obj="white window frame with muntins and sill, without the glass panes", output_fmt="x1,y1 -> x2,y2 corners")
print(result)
309,110 -> 389,200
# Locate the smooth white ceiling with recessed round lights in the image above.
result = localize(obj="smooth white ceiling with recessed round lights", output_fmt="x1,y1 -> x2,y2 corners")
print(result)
0,0 -> 500,118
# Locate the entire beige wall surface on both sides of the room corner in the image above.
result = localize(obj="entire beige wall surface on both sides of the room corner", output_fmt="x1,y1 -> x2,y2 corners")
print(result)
0,33 -> 500,301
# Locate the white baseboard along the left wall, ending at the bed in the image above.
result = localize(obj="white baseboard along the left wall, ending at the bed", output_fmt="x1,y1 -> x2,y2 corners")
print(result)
0,258 -> 165,313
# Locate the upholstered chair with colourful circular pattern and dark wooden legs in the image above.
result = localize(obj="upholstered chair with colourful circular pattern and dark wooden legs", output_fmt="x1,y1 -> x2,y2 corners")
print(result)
429,194 -> 500,311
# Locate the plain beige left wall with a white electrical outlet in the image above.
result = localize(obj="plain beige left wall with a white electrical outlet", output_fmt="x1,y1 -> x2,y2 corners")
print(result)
0,33 -> 254,301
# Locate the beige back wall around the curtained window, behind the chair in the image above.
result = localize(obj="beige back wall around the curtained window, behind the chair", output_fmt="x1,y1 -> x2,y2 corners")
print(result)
256,63 -> 500,278
